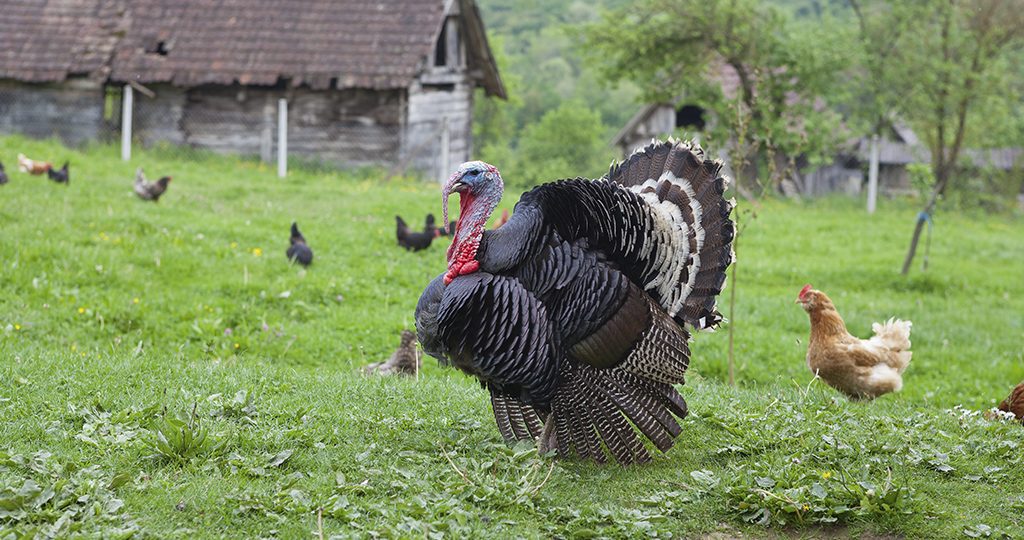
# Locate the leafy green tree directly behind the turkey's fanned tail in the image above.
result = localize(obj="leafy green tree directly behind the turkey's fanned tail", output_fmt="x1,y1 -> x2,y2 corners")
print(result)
581,0 -> 844,193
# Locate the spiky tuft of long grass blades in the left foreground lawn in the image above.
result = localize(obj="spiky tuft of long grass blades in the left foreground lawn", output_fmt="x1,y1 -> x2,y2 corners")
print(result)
146,406 -> 227,465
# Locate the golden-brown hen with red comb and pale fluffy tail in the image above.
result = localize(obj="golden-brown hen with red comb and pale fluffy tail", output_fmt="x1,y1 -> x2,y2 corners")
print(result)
797,285 -> 911,400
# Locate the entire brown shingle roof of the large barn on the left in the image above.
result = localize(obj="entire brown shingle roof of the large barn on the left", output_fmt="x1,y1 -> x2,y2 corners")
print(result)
0,0 -> 504,95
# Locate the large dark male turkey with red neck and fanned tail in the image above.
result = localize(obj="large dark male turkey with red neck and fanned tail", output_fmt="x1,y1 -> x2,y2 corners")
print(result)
416,139 -> 734,464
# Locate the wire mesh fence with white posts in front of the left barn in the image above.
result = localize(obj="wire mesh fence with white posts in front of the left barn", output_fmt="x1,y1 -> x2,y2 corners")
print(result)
0,82 -> 453,178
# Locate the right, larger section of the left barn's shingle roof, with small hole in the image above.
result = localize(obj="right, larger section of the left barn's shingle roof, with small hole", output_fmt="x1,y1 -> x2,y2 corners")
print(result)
112,0 -> 444,88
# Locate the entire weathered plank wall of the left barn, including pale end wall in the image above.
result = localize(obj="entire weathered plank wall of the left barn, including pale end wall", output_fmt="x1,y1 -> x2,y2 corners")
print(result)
0,75 -> 473,178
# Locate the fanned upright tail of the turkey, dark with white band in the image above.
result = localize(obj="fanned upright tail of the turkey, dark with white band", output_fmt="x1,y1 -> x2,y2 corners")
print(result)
607,139 -> 735,330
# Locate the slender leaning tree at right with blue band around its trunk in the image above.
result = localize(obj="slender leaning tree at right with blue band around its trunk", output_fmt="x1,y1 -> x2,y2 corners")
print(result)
849,0 -> 1024,275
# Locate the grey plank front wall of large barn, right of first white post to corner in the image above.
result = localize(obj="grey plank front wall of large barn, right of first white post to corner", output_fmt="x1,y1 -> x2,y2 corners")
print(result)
135,85 -> 401,166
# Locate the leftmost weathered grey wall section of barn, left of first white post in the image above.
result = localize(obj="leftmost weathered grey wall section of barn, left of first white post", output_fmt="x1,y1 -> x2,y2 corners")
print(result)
0,79 -> 111,144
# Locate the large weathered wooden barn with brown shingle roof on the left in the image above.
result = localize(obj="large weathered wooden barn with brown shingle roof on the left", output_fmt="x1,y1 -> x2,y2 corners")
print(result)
0,0 -> 505,176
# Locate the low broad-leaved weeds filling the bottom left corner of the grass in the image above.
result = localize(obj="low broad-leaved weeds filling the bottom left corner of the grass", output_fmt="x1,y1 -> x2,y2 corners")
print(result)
0,452 -> 139,538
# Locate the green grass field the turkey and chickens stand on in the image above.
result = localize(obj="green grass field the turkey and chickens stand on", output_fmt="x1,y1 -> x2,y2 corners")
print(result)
0,137 -> 1024,538
